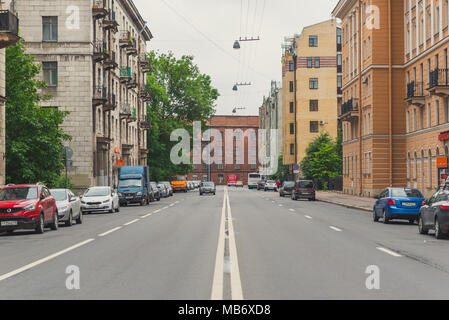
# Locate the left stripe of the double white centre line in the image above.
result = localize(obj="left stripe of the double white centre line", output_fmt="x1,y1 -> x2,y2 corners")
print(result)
211,188 -> 226,300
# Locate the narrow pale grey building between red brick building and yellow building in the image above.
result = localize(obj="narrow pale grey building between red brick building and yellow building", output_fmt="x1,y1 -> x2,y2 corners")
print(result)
259,81 -> 283,172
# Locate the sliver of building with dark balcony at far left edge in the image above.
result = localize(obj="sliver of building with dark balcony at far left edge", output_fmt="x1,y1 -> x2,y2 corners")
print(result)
0,3 -> 19,186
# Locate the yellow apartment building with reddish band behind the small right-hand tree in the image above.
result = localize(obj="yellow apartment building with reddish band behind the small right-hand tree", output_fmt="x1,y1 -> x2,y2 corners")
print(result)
282,19 -> 341,175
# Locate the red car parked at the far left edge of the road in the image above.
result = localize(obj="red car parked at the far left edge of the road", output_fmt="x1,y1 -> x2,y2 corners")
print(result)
0,183 -> 58,233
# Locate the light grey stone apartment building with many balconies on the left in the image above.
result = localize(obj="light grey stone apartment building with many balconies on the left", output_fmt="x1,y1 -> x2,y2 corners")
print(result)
12,0 -> 152,188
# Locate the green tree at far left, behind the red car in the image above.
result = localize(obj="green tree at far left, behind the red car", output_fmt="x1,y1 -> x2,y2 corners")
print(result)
6,41 -> 71,187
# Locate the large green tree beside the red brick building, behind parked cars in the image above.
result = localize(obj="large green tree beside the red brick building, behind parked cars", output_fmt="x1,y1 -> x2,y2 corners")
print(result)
147,51 -> 219,180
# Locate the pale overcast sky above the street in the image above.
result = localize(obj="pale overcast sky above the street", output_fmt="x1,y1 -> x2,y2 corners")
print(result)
134,0 -> 338,115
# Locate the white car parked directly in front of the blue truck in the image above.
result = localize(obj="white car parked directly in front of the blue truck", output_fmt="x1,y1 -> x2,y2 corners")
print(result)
81,187 -> 120,213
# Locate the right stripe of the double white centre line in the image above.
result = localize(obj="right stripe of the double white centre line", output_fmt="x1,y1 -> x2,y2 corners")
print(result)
225,191 -> 243,300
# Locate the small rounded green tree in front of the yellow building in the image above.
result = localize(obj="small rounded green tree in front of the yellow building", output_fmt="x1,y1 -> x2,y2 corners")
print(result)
301,133 -> 342,188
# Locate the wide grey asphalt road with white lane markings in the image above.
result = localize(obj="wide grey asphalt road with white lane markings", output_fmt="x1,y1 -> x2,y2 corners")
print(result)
0,188 -> 449,300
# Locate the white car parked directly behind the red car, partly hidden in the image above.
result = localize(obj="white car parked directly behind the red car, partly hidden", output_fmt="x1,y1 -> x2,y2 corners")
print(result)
50,189 -> 83,227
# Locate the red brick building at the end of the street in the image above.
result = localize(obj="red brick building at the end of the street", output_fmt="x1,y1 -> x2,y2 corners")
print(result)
188,116 -> 259,185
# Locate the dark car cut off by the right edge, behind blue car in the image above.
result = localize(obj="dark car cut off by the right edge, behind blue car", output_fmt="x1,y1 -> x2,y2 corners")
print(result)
418,190 -> 449,239
